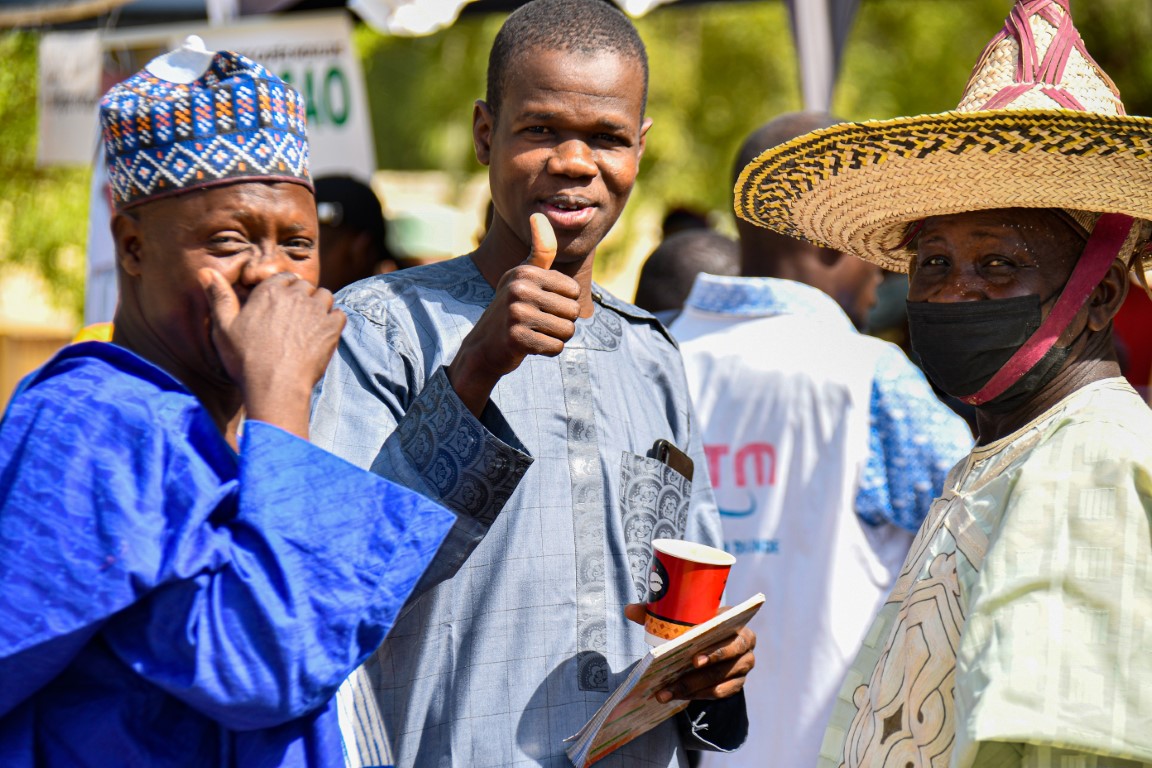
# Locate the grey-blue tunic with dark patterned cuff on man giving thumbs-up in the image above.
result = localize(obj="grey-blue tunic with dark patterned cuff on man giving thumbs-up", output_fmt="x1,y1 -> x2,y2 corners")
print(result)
312,258 -> 746,768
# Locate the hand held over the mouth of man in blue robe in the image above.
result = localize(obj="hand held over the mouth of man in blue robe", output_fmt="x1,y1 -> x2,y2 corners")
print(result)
197,268 -> 344,440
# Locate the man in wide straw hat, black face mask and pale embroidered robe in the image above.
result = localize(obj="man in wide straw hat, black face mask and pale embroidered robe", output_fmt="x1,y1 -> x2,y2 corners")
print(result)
735,0 -> 1152,768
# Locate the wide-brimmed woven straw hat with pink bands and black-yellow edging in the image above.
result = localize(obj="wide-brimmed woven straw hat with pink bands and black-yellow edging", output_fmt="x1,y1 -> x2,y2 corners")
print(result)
735,0 -> 1152,272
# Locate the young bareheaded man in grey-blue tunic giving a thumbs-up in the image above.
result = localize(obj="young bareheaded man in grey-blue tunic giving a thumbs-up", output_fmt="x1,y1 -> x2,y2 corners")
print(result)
312,0 -> 756,768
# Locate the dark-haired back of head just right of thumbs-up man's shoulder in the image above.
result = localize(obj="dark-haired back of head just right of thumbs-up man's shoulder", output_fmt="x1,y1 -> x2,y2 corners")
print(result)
632,229 -> 740,312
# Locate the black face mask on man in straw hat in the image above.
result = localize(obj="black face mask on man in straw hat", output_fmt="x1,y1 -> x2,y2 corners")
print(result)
908,294 -> 1070,413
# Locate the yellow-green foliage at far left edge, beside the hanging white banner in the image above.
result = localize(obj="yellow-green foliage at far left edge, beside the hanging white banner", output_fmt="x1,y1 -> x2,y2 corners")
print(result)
0,32 -> 91,320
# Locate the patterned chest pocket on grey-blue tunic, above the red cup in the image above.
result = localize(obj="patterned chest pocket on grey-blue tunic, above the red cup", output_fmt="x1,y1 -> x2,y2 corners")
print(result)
620,451 -> 692,601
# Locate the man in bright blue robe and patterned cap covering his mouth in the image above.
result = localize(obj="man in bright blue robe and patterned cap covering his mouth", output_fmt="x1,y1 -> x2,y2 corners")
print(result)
0,39 -> 467,768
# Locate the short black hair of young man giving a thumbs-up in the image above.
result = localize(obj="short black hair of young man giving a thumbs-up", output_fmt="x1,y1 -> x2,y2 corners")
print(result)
484,0 -> 649,115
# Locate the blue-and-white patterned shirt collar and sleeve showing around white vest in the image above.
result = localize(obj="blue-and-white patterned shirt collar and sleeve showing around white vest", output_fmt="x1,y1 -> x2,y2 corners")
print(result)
687,275 -> 972,532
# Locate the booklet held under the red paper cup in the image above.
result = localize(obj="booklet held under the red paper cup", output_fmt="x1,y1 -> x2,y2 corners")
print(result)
564,593 -> 764,768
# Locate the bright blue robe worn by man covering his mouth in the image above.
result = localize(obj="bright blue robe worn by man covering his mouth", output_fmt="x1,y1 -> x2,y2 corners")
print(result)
0,342 -> 453,768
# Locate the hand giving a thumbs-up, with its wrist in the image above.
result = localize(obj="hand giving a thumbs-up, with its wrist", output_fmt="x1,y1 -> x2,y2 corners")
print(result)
448,213 -> 579,416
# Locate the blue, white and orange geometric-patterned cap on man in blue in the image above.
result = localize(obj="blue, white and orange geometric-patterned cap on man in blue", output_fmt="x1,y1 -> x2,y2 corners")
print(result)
100,36 -> 312,211
